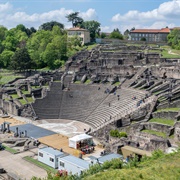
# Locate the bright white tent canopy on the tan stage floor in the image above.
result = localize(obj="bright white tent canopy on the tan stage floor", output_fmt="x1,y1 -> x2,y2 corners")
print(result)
69,134 -> 92,149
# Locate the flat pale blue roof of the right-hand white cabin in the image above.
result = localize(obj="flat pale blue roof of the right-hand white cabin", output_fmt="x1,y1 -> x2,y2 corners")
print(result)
59,155 -> 90,169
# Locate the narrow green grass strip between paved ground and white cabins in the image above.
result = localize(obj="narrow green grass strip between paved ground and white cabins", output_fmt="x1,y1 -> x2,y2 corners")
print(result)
23,156 -> 57,174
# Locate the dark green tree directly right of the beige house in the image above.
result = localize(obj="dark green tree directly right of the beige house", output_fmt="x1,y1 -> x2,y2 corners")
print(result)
81,21 -> 101,41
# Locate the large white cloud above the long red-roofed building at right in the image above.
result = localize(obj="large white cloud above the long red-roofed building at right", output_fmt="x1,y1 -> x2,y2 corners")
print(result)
109,0 -> 180,32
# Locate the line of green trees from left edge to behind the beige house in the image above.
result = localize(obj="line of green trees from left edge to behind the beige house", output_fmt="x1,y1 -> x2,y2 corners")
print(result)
0,12 -> 128,70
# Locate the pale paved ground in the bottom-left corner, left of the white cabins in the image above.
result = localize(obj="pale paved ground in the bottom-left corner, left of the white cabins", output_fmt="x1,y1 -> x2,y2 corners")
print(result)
0,151 -> 47,180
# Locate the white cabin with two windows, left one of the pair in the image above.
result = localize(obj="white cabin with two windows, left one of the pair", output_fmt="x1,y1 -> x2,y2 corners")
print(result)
38,147 -> 65,169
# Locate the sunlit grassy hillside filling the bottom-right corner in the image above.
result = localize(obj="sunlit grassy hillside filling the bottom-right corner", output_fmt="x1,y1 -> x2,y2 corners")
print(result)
84,151 -> 180,180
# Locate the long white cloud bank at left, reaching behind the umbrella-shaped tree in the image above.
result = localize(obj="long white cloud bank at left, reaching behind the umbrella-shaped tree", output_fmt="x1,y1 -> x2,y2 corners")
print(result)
0,3 -> 97,28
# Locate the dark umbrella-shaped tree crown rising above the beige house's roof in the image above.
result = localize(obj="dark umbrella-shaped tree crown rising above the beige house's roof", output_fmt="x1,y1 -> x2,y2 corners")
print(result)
66,12 -> 84,27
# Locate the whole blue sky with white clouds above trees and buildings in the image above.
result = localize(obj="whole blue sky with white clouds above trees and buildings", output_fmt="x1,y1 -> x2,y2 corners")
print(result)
0,0 -> 180,33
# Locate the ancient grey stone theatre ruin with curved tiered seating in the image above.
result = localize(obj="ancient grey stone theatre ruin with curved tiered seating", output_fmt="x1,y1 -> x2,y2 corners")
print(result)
0,44 -> 180,151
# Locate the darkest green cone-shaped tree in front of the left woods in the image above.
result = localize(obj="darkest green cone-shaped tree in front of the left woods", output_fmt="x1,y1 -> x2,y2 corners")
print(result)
10,48 -> 32,71
